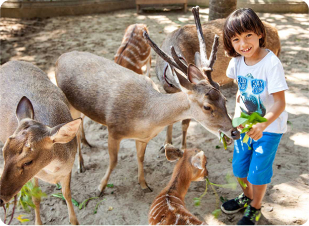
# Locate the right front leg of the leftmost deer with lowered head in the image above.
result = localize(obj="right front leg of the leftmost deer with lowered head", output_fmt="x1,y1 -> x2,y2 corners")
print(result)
60,173 -> 79,225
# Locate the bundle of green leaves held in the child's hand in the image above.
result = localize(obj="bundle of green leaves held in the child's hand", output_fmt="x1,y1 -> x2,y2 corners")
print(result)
232,112 -> 267,150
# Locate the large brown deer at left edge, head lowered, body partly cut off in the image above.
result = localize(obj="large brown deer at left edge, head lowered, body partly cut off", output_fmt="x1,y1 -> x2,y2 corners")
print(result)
0,61 -> 81,224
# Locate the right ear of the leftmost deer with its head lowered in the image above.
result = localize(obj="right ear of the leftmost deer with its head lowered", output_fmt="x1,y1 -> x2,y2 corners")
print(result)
50,118 -> 82,144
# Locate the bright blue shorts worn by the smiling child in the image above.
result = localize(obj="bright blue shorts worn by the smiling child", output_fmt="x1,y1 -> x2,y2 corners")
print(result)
232,132 -> 282,185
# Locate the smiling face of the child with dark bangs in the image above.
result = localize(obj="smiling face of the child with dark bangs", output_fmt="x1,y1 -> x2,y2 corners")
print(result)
231,31 -> 262,59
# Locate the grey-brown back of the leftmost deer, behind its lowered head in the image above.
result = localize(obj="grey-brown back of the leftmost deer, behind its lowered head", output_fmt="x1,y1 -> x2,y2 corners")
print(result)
0,61 -> 72,142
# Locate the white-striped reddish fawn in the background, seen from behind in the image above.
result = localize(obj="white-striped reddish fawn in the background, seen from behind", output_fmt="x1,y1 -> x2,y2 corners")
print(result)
114,24 -> 151,77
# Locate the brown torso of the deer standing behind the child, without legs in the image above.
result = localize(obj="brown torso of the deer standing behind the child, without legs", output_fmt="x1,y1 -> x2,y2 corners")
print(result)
156,19 -> 281,89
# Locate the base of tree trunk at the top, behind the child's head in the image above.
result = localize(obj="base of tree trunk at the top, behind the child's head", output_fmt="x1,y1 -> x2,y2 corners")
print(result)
208,0 -> 237,21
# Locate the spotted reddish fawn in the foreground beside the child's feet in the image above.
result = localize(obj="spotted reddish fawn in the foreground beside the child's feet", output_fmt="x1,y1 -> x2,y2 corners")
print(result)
148,145 -> 208,225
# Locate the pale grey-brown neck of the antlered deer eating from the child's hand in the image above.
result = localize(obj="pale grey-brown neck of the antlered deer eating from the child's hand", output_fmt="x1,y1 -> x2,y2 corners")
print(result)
150,92 -> 191,126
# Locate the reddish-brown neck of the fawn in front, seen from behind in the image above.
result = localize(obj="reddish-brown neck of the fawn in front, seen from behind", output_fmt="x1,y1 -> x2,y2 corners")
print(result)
164,160 -> 191,201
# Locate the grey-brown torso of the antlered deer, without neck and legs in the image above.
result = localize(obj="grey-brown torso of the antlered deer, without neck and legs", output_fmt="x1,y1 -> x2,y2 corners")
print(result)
56,51 -> 159,129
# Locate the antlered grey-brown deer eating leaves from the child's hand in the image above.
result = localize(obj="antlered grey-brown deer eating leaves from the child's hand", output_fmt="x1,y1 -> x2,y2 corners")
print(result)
55,13 -> 239,194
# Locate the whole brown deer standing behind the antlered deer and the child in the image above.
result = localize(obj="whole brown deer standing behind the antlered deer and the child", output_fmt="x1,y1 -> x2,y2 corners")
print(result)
156,6 -> 281,151
